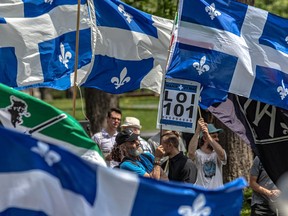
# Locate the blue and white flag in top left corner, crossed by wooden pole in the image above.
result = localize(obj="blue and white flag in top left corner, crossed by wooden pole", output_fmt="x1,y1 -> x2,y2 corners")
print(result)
0,0 -> 93,89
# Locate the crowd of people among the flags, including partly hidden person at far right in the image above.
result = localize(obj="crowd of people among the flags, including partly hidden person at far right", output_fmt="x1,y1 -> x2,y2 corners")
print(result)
92,108 -> 280,216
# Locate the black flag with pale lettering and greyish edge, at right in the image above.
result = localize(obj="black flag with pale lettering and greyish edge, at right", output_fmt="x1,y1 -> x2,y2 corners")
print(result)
209,94 -> 288,184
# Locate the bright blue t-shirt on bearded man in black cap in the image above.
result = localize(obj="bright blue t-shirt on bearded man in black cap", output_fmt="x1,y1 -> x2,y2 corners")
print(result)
120,153 -> 154,176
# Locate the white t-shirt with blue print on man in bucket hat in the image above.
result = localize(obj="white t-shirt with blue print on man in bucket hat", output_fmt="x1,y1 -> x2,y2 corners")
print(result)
195,149 -> 227,188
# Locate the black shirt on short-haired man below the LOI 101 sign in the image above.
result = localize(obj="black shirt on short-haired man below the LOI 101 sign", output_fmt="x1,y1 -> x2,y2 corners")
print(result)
162,152 -> 197,183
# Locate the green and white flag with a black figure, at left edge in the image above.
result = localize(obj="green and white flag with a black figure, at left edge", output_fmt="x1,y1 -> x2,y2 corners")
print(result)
0,84 -> 106,166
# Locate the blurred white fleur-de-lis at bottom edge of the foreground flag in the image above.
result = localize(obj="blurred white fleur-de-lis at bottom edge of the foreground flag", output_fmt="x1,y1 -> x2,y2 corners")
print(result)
178,194 -> 211,216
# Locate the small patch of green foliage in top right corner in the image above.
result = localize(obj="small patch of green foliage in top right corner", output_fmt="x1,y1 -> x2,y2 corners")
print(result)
255,0 -> 288,18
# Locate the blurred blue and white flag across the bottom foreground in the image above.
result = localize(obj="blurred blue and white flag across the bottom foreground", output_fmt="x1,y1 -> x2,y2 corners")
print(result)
0,127 -> 247,216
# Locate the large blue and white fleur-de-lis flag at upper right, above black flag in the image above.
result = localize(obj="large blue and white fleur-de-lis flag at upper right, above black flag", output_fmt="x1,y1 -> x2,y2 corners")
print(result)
167,0 -> 288,109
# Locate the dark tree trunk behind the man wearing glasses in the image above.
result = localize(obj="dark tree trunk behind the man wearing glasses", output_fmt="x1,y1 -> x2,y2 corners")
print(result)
85,88 -> 119,135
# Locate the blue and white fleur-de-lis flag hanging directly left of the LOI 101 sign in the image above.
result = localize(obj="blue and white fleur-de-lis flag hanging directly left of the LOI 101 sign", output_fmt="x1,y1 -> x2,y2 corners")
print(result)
81,0 -> 173,94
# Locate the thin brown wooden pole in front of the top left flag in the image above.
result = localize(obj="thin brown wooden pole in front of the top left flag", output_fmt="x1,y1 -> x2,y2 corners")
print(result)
72,0 -> 81,118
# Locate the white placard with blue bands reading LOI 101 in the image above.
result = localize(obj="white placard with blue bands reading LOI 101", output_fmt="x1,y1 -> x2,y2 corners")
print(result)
158,78 -> 200,133
